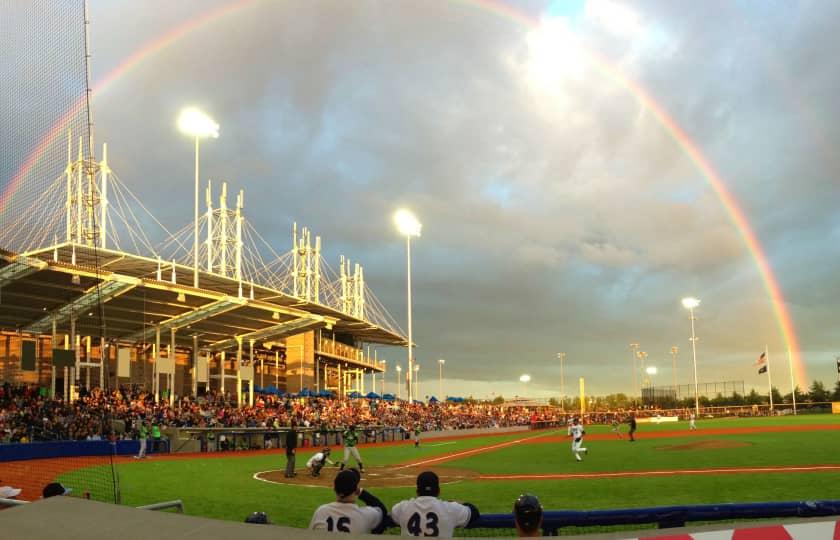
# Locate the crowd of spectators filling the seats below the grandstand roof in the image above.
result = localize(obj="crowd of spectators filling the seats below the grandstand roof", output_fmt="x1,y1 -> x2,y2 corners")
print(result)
0,384 -> 562,442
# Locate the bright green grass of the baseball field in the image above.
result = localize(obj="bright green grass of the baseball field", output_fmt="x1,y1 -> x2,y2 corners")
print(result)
62,415 -> 840,527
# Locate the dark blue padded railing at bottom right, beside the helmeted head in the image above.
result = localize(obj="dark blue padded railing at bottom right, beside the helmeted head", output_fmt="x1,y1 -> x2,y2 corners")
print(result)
473,501 -> 840,536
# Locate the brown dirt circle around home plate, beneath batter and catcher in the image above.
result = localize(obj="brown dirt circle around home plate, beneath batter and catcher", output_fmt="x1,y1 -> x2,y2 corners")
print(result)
254,465 -> 478,489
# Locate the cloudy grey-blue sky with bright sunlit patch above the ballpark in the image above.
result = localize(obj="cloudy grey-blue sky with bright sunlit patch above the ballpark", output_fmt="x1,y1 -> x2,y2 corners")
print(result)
14,0 -> 840,396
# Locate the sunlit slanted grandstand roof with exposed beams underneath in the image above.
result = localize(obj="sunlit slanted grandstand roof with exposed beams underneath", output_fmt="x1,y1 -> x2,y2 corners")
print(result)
0,243 -> 407,349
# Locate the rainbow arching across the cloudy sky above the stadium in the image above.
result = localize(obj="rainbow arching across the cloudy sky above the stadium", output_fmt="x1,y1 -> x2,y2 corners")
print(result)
0,0 -> 808,385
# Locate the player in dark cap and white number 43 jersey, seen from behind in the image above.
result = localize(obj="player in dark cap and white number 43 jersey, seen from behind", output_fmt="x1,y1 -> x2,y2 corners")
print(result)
391,471 -> 479,538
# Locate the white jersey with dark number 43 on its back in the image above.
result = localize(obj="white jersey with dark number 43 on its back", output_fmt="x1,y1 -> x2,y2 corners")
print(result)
391,497 -> 471,538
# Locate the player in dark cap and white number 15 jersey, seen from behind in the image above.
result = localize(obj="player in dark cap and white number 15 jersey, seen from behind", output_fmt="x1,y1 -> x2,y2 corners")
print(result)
309,469 -> 388,534
